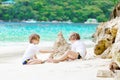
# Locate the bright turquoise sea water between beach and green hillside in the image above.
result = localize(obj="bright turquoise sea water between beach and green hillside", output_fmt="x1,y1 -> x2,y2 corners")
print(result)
0,23 -> 97,42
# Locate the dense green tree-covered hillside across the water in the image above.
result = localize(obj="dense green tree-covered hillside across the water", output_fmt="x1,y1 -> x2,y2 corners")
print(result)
0,0 -> 117,22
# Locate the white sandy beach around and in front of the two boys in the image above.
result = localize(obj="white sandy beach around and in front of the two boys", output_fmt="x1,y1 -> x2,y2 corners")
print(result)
0,42 -> 113,80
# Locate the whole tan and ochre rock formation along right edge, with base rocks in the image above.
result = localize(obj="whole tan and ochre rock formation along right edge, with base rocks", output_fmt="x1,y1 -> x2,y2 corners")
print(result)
92,3 -> 120,80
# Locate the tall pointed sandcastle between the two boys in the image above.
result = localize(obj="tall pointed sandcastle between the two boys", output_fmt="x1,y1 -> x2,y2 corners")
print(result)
50,32 -> 70,59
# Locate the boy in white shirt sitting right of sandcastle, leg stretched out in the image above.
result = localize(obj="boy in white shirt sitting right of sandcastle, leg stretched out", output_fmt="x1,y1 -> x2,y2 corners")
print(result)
48,32 -> 86,63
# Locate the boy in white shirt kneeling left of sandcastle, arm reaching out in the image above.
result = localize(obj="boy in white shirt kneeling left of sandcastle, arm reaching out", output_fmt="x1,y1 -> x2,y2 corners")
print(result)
22,34 -> 54,65
